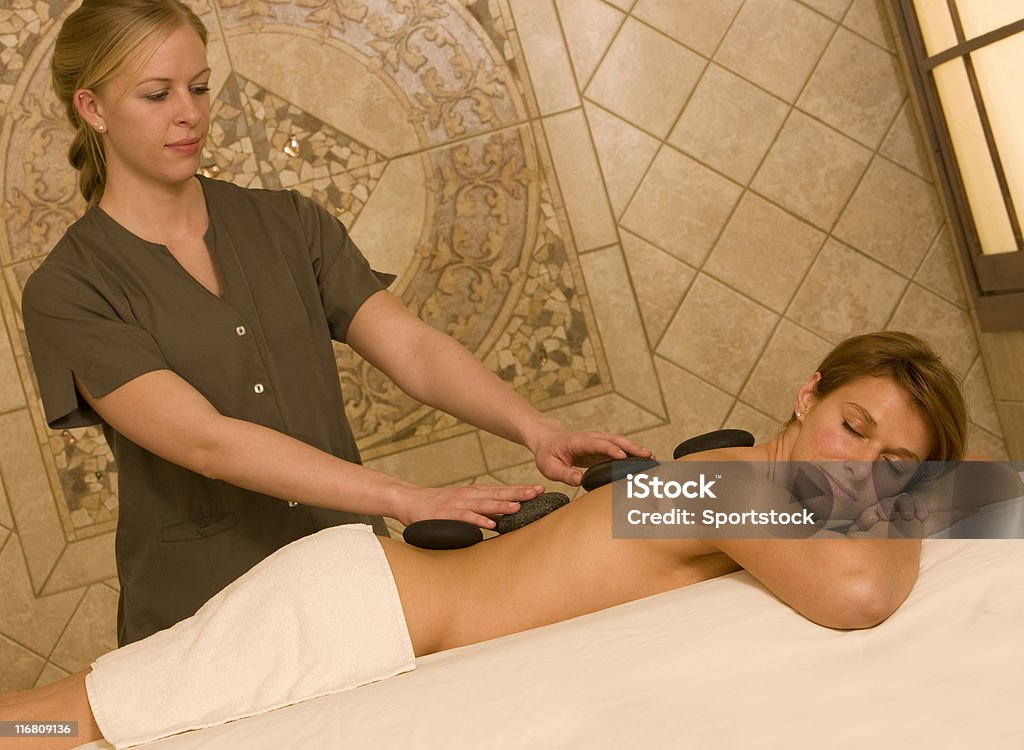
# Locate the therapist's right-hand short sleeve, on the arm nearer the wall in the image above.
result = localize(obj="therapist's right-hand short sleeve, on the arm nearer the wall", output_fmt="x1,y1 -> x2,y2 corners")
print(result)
292,192 -> 395,342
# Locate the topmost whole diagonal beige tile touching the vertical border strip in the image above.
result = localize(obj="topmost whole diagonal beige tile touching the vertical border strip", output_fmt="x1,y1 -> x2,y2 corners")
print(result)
586,19 -> 706,138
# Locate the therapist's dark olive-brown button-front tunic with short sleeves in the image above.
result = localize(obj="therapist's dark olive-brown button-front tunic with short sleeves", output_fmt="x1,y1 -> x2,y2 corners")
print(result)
23,178 -> 393,645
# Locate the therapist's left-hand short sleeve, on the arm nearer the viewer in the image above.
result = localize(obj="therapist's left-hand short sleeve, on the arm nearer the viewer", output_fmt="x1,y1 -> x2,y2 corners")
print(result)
22,262 -> 168,429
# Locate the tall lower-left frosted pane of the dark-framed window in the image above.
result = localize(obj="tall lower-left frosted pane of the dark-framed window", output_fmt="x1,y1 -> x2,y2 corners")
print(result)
933,58 -> 1017,254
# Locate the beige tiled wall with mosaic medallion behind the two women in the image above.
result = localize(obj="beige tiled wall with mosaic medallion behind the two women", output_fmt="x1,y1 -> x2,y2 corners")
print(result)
0,0 -> 1006,690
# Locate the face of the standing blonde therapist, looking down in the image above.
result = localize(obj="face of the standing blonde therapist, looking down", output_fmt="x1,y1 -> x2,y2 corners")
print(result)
76,26 -> 210,193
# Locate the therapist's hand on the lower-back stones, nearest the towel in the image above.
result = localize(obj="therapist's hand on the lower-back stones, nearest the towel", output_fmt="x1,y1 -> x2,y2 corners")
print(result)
394,485 -> 544,529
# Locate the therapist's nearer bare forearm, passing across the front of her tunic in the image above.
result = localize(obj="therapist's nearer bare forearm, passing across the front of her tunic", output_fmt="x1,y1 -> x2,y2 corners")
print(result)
190,417 -> 407,517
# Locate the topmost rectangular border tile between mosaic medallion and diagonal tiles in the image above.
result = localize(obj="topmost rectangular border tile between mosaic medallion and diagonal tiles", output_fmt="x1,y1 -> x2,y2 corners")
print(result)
509,0 -> 580,115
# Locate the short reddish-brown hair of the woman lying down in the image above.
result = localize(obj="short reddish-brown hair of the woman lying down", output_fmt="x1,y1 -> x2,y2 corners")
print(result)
791,331 -> 968,461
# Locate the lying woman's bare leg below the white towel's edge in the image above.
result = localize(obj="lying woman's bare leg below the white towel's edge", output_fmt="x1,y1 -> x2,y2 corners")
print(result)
0,669 -> 103,750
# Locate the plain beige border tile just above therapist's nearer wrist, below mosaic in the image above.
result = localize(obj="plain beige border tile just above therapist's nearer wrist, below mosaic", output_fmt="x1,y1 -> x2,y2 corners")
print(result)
366,432 -> 486,487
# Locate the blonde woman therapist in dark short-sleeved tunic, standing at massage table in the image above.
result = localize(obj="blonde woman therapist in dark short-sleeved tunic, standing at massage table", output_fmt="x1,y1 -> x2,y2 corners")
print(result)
23,0 -> 650,645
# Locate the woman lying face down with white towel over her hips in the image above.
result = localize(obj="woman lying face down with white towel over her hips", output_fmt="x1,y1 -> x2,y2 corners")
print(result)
0,333 -> 967,749
